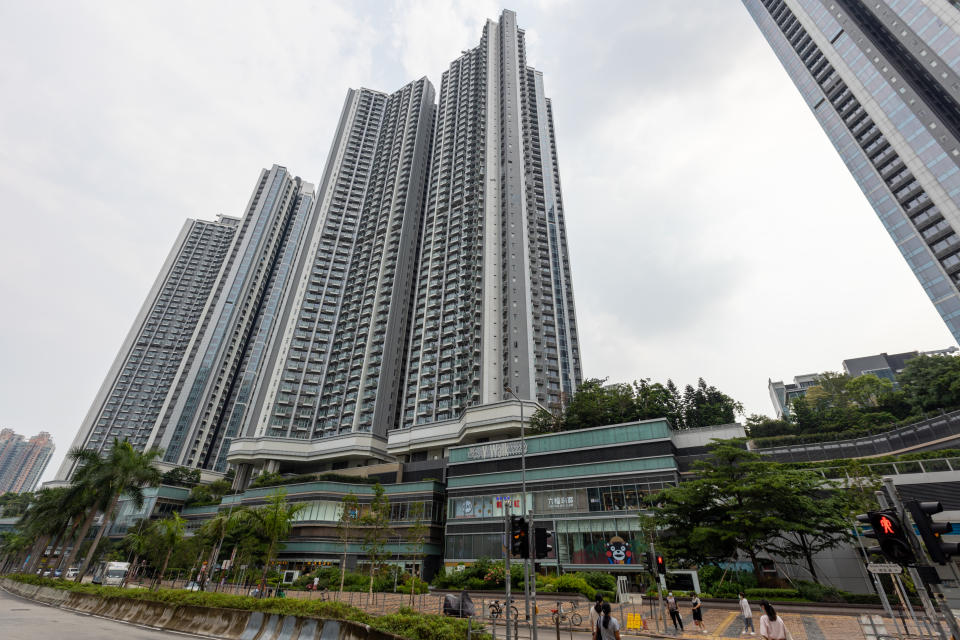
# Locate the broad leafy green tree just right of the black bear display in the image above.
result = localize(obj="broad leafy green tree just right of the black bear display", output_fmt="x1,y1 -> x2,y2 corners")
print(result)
656,440 -> 788,579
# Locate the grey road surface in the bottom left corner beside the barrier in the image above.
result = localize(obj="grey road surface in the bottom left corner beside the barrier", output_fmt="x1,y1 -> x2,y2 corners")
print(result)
0,590 -> 197,640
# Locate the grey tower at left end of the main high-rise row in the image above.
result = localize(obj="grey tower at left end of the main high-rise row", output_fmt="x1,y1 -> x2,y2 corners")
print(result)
57,216 -> 240,480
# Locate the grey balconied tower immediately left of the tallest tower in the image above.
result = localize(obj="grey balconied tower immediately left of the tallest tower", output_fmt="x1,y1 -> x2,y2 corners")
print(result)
231,78 -> 435,470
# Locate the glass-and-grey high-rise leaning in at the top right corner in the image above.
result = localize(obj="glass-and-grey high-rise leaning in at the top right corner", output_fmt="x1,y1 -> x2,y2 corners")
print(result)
744,0 -> 960,340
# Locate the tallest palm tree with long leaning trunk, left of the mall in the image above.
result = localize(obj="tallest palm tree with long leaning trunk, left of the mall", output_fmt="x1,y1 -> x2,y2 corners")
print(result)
77,438 -> 162,582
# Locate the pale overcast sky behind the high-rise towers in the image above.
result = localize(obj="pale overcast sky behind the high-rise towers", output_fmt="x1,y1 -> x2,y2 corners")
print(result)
0,0 -> 954,479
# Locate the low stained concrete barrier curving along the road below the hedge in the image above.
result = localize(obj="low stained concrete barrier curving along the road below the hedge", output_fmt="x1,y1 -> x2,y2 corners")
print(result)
0,578 -> 402,640
